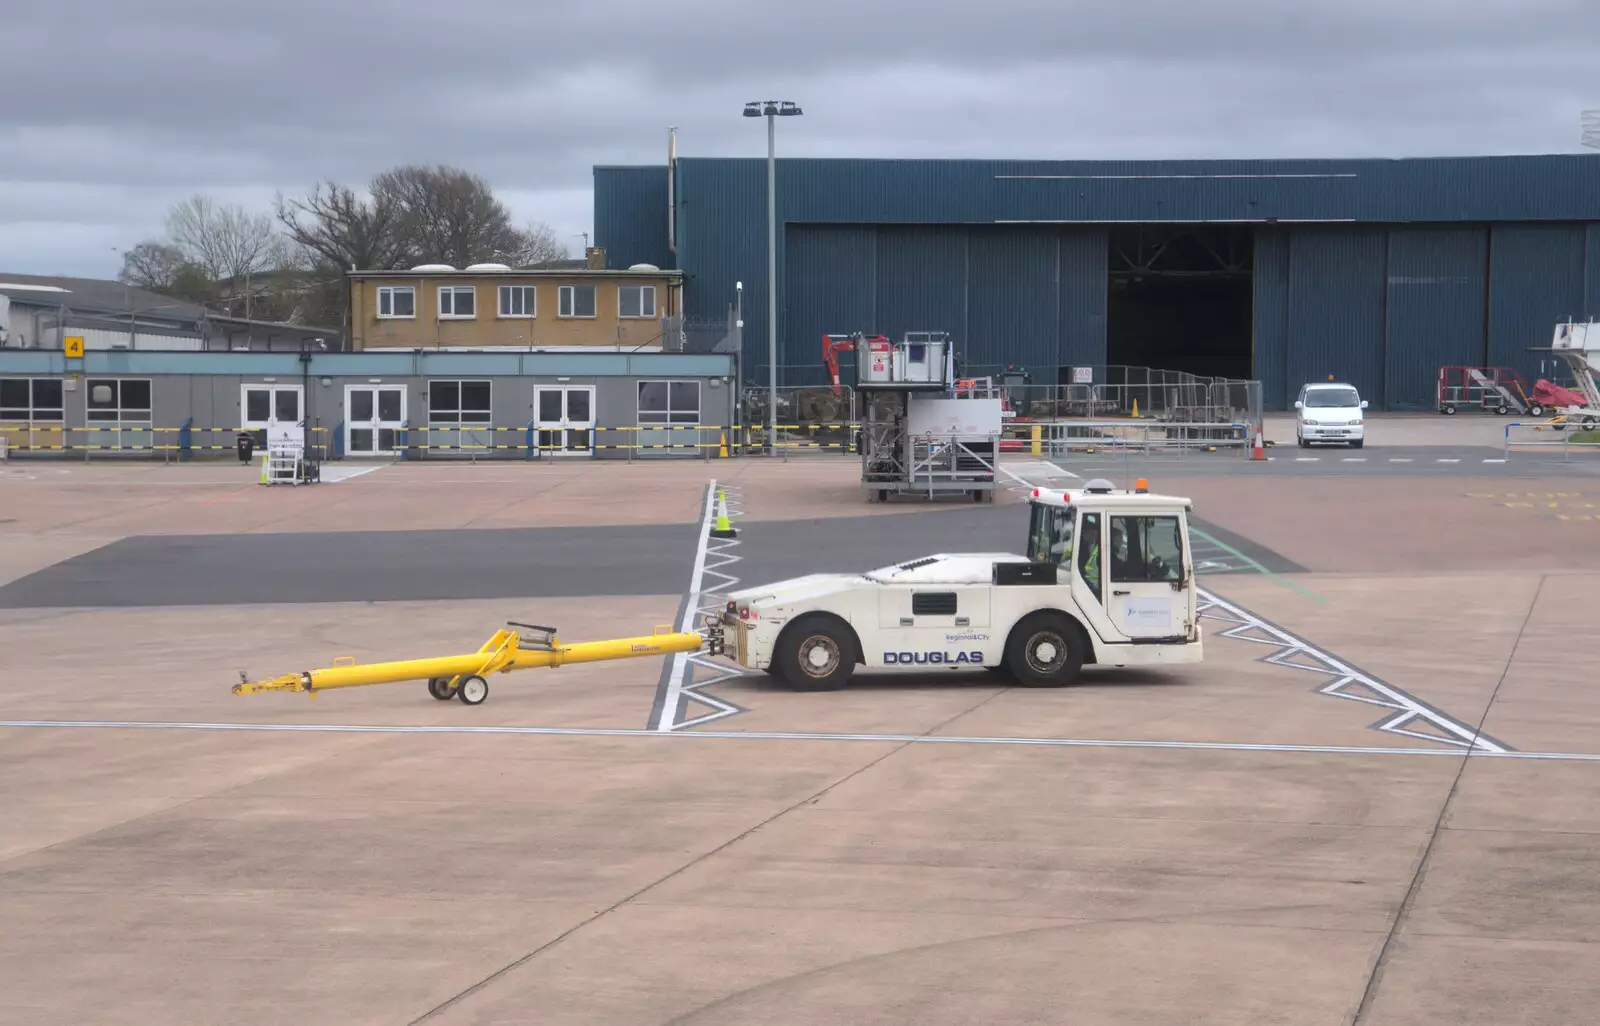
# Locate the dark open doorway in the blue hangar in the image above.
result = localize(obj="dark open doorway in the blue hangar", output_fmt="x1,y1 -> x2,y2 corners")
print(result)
1106,224 -> 1254,378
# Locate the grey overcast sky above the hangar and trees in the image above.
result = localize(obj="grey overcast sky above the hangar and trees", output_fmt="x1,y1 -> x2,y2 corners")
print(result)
0,0 -> 1600,277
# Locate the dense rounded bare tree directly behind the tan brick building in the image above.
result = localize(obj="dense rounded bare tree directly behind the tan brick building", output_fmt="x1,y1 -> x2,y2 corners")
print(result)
371,166 -> 523,267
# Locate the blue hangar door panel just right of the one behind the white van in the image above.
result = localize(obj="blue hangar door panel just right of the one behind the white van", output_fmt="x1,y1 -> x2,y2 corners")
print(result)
1373,226 -> 1488,410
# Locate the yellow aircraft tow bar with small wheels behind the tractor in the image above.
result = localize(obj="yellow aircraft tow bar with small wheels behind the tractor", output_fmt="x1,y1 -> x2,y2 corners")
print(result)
234,623 -> 723,706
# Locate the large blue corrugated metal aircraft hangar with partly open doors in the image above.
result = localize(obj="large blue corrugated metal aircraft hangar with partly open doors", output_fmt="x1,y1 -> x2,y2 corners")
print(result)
594,154 -> 1600,410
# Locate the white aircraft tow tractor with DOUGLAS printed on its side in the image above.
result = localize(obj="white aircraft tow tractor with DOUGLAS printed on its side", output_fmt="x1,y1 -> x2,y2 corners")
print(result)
706,479 -> 1202,691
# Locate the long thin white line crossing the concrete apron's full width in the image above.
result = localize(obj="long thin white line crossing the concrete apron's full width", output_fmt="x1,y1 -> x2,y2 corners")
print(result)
0,720 -> 1600,762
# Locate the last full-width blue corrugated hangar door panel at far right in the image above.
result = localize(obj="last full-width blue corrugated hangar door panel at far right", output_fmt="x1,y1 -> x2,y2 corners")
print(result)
1488,224 -> 1584,374
